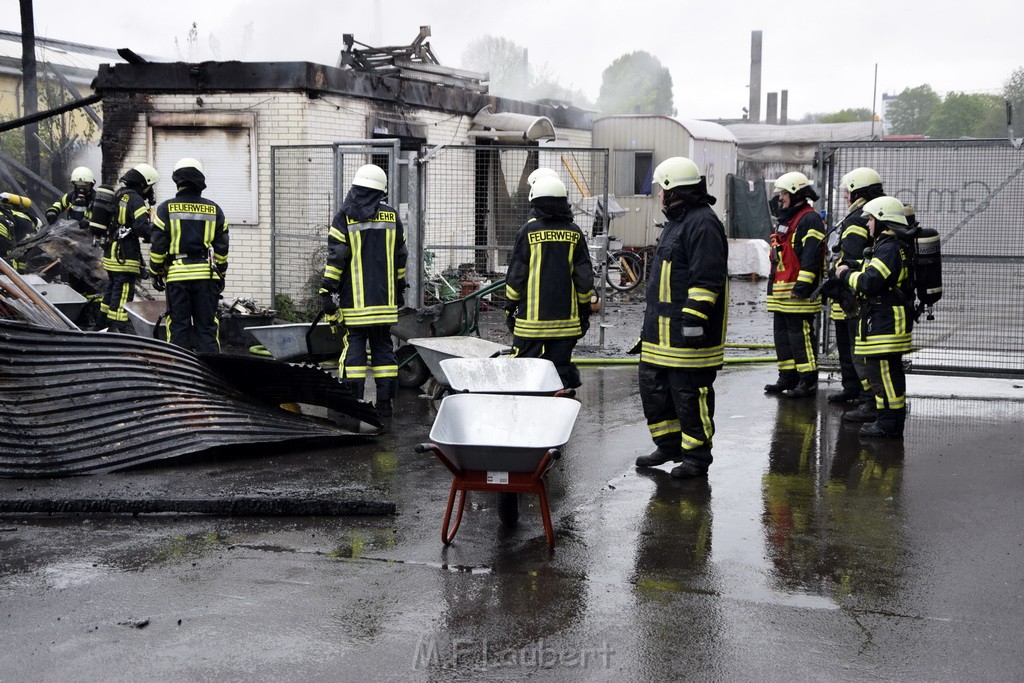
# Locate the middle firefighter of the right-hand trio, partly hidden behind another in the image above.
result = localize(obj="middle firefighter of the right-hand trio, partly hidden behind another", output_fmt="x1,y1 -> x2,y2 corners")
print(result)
827,168 -> 885,405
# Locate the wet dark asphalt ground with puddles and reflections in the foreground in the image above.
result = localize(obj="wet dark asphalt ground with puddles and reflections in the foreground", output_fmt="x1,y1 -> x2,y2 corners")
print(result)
0,280 -> 1024,681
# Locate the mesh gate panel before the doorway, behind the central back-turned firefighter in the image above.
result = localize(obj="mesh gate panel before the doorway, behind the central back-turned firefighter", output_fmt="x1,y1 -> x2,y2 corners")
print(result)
420,145 -> 608,346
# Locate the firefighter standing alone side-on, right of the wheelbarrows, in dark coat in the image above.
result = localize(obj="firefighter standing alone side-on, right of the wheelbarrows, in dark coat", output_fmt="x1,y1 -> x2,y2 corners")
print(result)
631,157 -> 729,479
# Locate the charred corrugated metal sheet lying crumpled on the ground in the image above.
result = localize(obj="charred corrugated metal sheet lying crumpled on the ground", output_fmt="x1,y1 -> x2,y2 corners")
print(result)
0,319 -> 379,477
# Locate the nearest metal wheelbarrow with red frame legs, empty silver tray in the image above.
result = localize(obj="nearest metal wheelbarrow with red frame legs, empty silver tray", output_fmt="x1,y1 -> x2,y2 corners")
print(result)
416,393 -> 580,550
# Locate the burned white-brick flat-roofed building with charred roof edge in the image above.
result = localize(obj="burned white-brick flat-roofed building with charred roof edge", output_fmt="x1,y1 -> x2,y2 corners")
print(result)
93,28 -> 593,301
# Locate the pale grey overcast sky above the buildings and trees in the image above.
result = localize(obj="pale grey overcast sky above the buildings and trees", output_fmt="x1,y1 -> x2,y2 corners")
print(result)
0,0 -> 1024,120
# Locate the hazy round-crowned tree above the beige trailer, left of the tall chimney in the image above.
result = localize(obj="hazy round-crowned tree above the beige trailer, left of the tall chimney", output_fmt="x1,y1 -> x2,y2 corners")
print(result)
597,50 -> 676,116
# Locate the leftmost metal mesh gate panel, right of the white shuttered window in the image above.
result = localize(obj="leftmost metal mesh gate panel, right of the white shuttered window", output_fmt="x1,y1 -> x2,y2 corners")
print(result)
270,140 -> 399,319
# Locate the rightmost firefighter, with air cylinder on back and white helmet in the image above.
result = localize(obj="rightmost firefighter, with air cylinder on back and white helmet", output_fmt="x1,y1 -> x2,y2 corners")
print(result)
836,197 -> 914,438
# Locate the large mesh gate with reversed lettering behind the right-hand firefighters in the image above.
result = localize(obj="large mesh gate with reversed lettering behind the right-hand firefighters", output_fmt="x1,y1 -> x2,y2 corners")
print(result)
819,140 -> 1024,375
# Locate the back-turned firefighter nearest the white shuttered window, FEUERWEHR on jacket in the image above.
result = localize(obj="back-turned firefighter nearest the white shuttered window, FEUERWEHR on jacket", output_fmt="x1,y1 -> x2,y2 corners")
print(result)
150,158 -> 228,353
